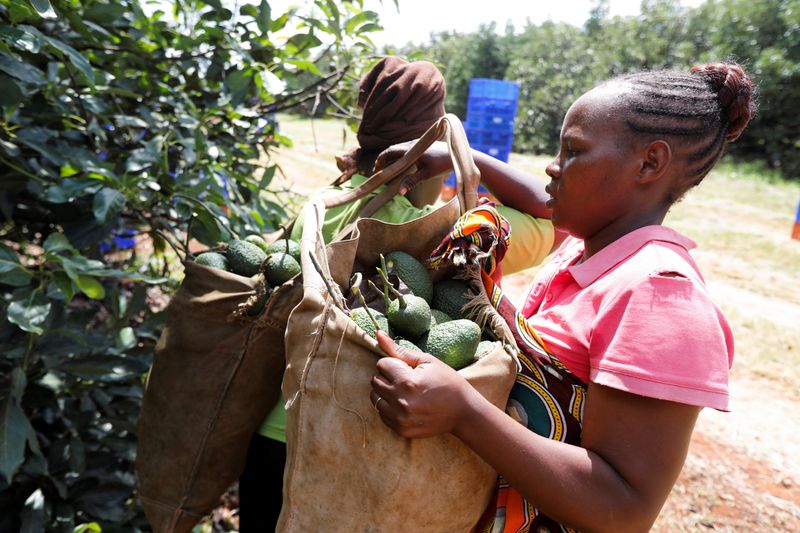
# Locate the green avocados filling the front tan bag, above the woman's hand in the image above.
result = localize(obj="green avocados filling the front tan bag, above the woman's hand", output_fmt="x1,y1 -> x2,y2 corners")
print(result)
350,251 -> 493,370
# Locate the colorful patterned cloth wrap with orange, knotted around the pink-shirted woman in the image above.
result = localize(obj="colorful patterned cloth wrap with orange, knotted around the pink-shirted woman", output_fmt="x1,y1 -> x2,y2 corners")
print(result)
428,199 -> 586,533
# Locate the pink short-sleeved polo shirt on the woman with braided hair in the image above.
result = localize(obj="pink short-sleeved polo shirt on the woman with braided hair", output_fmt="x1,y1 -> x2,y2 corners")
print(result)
522,222 -> 733,411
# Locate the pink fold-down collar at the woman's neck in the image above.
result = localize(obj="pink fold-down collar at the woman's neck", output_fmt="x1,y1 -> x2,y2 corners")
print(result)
567,226 -> 697,287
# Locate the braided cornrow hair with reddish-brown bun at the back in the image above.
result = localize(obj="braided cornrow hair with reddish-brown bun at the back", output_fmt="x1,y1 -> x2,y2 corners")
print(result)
617,63 -> 756,202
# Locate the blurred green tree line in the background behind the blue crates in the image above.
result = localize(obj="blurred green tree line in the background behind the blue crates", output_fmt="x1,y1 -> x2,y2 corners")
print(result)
400,0 -> 800,179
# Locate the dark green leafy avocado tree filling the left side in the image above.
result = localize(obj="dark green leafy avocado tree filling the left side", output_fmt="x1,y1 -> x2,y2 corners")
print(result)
0,0 -> 379,531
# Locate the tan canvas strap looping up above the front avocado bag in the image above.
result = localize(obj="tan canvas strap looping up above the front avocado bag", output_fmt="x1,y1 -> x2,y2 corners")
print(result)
300,114 -> 480,290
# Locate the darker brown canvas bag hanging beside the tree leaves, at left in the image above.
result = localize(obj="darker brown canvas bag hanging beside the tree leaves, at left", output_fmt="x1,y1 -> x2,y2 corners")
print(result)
135,117 -> 468,533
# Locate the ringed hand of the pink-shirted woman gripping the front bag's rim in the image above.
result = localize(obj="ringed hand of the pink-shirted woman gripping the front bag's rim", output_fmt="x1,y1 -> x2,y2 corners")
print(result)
370,331 -> 475,438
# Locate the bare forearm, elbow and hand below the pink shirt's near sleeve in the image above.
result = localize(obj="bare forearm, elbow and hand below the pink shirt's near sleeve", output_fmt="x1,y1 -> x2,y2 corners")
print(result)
372,335 -> 700,531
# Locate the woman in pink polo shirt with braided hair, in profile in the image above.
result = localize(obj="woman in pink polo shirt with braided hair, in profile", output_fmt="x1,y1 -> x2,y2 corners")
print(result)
371,60 -> 755,532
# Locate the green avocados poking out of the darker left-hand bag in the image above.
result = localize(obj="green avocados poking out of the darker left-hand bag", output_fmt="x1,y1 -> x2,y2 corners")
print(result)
194,235 -> 300,315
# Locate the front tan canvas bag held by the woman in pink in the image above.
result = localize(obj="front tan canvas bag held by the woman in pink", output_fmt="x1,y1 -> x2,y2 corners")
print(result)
277,115 -> 516,533
